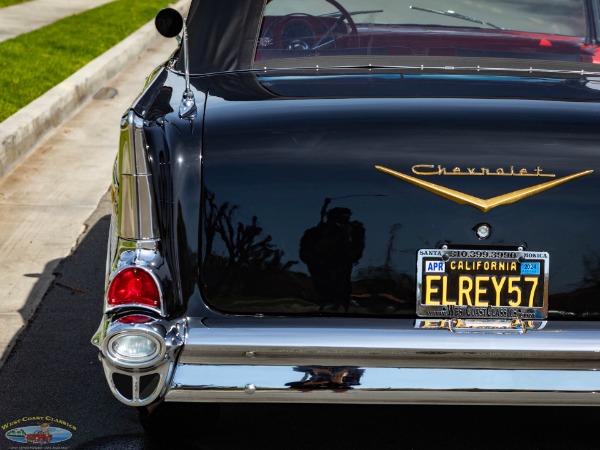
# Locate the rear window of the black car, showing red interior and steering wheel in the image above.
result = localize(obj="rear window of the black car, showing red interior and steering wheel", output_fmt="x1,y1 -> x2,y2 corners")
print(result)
254,0 -> 596,67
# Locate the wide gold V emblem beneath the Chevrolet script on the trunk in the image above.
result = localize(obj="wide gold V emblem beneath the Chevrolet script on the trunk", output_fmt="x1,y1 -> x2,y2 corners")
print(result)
375,166 -> 593,212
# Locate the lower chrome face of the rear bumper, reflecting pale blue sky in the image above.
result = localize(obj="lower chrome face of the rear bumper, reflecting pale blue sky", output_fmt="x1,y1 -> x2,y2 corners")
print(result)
166,365 -> 600,406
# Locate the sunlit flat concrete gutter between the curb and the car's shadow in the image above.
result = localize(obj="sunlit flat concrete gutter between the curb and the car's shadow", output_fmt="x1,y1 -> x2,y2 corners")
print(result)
0,4 -> 182,367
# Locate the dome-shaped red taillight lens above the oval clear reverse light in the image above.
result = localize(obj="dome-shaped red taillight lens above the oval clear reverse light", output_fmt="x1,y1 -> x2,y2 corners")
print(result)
107,267 -> 160,309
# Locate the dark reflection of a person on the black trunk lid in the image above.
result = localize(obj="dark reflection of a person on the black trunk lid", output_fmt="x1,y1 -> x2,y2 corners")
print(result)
300,203 -> 365,312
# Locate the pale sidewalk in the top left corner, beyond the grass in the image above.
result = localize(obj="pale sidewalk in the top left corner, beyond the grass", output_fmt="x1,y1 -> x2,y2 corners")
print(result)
0,0 -> 113,42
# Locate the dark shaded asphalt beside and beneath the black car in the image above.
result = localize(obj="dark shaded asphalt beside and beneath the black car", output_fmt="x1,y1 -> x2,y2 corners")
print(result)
0,196 -> 600,450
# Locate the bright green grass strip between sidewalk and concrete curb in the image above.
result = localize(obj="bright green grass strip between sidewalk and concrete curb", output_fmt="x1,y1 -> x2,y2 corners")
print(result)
0,0 -> 170,122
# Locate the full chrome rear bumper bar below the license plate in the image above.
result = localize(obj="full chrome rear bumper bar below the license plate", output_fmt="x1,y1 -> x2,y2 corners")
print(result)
166,318 -> 600,405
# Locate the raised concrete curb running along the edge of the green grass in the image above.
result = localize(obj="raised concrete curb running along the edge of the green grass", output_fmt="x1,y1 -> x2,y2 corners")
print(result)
0,0 -> 188,177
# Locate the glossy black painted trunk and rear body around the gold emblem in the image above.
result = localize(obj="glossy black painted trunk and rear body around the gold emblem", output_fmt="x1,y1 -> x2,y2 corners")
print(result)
135,71 -> 600,317
